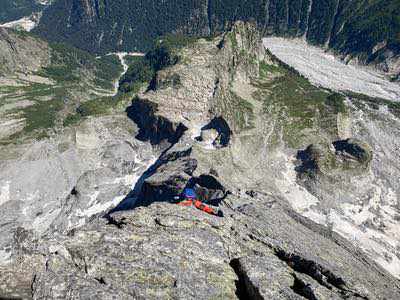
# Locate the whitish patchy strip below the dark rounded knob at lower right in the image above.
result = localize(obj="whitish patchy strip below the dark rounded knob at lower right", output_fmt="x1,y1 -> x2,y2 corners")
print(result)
275,148 -> 400,278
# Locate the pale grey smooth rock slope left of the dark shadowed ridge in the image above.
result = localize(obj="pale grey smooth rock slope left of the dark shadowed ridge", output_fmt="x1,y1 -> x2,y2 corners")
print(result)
0,115 -> 156,247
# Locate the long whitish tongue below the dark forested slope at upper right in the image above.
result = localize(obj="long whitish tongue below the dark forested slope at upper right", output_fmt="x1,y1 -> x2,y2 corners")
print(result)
263,37 -> 400,101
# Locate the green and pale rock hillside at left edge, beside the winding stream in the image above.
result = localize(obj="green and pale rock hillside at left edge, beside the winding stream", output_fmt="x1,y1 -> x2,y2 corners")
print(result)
0,28 -> 122,144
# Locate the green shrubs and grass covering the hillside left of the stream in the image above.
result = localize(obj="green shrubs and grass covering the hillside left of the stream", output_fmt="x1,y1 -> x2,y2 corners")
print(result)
0,38 -> 125,143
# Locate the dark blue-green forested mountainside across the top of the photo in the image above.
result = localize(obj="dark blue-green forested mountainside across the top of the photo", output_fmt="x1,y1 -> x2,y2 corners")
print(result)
37,0 -> 400,67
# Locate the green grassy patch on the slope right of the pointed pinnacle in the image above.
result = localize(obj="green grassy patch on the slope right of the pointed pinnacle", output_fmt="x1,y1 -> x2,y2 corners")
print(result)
255,63 -> 346,148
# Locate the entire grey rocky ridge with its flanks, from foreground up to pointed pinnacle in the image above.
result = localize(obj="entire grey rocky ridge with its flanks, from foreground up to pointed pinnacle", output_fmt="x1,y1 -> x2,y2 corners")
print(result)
0,22 -> 400,299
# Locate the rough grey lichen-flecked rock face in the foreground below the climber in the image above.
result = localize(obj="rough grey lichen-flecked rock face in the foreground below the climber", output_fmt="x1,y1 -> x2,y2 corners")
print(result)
0,191 -> 399,299
